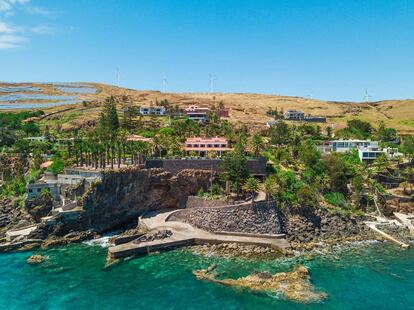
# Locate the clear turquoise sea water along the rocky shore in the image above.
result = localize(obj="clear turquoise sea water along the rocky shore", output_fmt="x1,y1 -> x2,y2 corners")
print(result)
0,244 -> 414,310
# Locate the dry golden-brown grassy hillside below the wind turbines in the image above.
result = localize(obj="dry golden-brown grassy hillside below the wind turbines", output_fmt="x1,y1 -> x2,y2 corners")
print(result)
0,83 -> 414,134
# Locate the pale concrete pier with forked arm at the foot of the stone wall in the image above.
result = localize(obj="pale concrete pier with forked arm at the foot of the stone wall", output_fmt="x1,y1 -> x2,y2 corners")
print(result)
108,210 -> 290,259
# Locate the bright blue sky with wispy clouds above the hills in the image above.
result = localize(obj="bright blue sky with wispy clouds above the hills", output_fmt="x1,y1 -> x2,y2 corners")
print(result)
0,0 -> 414,101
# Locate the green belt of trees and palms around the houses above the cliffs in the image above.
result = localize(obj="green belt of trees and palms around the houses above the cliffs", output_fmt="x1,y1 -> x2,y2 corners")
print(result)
0,92 -> 414,218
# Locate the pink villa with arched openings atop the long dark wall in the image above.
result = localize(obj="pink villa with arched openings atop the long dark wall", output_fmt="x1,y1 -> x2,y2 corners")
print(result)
184,137 -> 231,157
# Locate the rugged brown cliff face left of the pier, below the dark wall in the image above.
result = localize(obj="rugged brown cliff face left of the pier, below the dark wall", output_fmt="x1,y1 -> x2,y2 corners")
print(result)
71,168 -> 210,232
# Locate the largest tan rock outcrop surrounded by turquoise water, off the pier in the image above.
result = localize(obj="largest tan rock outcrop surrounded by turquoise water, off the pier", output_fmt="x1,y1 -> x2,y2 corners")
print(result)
193,266 -> 327,303
